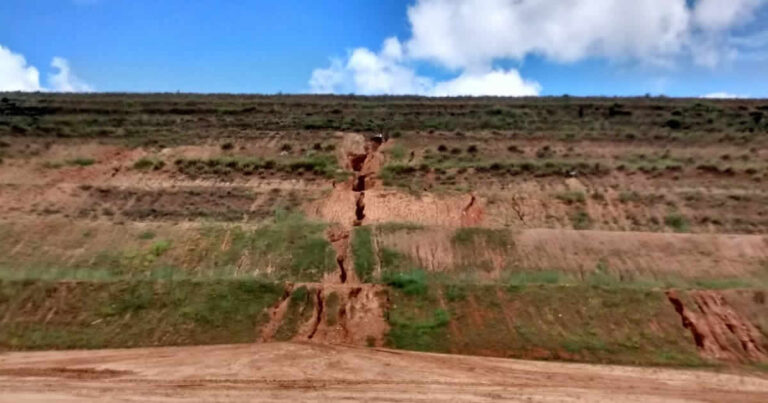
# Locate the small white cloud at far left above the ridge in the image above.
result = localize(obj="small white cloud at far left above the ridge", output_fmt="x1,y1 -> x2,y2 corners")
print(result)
0,45 -> 93,92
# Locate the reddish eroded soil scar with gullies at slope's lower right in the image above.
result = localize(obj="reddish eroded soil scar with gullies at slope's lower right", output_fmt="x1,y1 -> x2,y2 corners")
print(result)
666,290 -> 768,362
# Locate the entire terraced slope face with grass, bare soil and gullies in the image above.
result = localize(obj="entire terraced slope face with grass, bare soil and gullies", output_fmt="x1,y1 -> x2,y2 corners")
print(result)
0,94 -> 768,365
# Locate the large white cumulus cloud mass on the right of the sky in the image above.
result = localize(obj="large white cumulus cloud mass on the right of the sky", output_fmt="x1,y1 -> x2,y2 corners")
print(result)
310,0 -> 768,95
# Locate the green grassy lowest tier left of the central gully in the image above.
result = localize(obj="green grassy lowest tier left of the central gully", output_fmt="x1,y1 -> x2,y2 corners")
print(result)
0,280 -> 283,350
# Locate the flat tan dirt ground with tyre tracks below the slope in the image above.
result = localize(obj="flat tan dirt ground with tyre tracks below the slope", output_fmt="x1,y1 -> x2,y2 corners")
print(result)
0,343 -> 768,402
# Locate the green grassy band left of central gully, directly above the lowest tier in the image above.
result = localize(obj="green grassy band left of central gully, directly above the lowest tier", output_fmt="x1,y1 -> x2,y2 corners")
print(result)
0,212 -> 336,281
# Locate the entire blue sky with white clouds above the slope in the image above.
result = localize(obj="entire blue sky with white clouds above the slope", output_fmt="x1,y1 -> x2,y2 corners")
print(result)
0,0 -> 768,98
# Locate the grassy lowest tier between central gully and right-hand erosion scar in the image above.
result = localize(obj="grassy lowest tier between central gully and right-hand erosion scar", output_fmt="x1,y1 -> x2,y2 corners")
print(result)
389,286 -> 712,366
